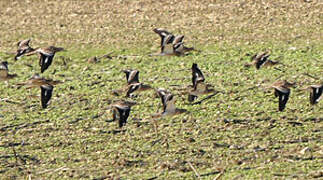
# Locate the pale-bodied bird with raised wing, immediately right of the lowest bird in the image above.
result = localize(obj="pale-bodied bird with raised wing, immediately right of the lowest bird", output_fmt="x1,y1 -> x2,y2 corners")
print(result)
152,89 -> 187,118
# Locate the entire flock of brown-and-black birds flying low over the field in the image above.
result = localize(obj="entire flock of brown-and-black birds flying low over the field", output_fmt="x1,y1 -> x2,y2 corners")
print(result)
0,28 -> 323,128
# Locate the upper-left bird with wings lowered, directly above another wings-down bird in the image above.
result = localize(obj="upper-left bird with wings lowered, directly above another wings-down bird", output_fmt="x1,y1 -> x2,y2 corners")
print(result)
26,46 -> 64,73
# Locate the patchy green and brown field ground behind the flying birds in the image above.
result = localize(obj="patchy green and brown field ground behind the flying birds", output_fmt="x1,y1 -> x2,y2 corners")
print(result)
0,0 -> 323,179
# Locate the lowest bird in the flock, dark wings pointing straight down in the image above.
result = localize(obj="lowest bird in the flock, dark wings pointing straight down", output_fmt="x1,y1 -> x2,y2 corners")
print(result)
111,101 -> 136,128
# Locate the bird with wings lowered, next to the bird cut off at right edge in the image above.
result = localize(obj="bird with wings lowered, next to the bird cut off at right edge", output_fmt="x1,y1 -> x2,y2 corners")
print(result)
270,80 -> 295,111
